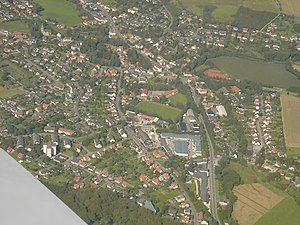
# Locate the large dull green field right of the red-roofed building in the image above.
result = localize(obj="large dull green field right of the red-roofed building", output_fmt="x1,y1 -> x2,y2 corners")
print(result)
212,56 -> 300,88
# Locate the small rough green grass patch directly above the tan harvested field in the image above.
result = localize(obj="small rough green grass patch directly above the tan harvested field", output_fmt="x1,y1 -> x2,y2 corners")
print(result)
229,162 -> 260,184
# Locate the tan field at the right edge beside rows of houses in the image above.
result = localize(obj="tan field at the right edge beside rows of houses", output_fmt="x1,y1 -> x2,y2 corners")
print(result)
280,95 -> 300,148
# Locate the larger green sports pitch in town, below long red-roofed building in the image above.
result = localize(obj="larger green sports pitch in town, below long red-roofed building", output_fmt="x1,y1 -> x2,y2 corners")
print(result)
135,101 -> 181,122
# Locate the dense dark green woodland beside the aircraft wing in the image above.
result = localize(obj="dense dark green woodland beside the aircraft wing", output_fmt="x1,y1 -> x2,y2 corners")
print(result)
46,183 -> 180,225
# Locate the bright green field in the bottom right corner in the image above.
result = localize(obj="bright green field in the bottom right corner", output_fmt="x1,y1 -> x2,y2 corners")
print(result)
255,197 -> 300,225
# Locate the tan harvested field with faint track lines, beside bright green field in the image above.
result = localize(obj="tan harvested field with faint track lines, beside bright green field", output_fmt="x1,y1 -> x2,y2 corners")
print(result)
233,183 -> 285,225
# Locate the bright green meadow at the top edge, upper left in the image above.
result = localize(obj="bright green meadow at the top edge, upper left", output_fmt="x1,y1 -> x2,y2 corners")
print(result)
34,0 -> 82,26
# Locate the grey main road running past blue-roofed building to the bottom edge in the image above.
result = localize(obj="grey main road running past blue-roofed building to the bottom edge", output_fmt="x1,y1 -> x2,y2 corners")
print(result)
189,85 -> 221,224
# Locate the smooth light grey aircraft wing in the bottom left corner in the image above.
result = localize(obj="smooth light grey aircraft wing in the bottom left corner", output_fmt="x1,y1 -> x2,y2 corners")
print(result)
0,149 -> 86,225
